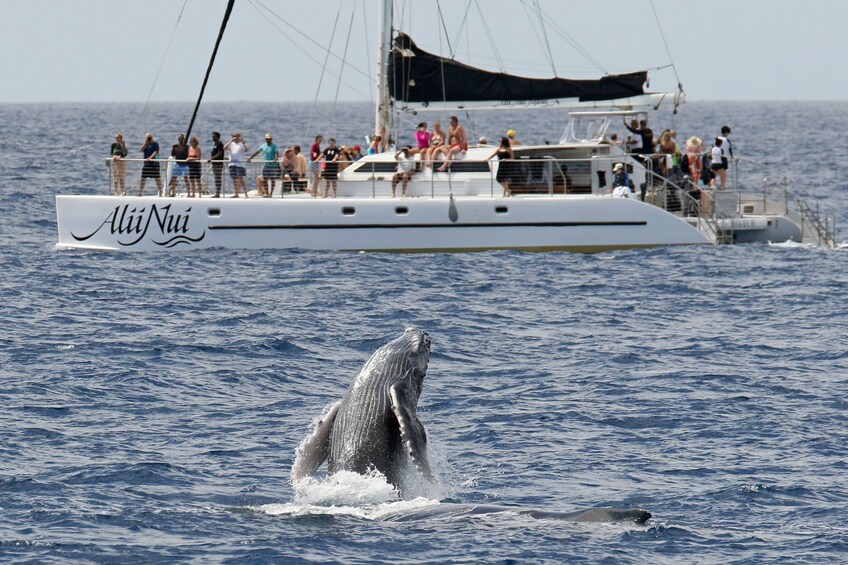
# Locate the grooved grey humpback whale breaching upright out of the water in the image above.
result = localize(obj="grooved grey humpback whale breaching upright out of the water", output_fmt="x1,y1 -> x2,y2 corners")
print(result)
291,328 -> 436,490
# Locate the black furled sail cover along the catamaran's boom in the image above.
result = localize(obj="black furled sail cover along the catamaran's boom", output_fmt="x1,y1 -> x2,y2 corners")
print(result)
388,33 -> 648,107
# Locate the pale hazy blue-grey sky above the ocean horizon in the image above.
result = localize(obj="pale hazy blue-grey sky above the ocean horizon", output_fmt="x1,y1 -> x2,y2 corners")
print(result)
0,0 -> 848,103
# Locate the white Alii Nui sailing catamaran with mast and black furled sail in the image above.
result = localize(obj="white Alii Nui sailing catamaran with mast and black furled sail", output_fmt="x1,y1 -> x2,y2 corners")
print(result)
56,0 -> 834,252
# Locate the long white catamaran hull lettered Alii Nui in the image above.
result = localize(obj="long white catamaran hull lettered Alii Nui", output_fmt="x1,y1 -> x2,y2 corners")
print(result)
56,195 -> 710,253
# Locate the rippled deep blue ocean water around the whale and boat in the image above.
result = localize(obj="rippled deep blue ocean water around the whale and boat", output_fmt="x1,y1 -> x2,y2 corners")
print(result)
0,103 -> 848,563
